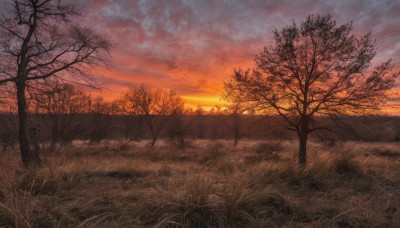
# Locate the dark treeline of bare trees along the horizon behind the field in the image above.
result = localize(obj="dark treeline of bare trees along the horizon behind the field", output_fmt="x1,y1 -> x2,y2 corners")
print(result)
0,81 -> 400,151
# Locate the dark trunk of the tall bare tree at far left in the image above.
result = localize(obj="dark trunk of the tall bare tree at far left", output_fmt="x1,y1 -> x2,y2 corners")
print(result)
17,82 -> 40,168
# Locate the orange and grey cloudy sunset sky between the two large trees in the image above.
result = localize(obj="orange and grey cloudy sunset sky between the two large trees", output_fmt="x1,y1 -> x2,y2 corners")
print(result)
79,0 -> 400,110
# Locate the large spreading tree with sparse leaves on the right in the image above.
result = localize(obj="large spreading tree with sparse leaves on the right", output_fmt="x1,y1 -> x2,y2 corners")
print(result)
225,15 -> 399,166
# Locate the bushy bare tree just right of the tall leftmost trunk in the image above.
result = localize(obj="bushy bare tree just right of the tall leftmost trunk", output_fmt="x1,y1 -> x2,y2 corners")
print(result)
32,80 -> 91,152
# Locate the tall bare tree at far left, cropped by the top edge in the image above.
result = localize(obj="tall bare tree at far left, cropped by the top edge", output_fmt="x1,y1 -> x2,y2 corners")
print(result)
0,0 -> 110,167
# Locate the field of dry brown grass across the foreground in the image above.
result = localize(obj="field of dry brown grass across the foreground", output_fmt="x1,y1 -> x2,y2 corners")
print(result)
0,140 -> 400,227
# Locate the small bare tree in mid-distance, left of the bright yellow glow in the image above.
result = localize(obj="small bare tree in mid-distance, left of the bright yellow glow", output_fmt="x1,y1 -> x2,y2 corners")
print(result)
125,84 -> 183,146
